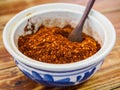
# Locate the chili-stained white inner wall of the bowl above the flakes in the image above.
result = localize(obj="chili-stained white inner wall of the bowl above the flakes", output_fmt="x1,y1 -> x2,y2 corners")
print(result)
12,11 -> 105,48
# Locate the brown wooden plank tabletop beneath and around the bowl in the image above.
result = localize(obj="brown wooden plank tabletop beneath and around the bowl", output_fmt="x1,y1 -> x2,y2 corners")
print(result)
0,0 -> 120,90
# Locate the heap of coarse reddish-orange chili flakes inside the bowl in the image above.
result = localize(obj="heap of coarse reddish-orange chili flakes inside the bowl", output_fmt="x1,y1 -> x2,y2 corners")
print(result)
18,25 -> 101,64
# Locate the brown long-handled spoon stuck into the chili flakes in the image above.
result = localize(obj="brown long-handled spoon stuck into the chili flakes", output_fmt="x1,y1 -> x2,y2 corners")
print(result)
68,0 -> 95,42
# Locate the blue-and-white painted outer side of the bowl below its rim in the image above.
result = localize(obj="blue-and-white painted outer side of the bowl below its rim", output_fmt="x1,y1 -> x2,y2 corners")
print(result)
15,60 -> 102,87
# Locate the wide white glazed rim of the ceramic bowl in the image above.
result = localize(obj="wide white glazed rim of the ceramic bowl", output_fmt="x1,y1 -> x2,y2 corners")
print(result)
3,3 -> 116,71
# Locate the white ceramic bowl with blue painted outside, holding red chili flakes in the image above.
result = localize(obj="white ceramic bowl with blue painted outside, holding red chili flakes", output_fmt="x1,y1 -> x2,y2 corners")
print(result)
3,3 -> 116,86
